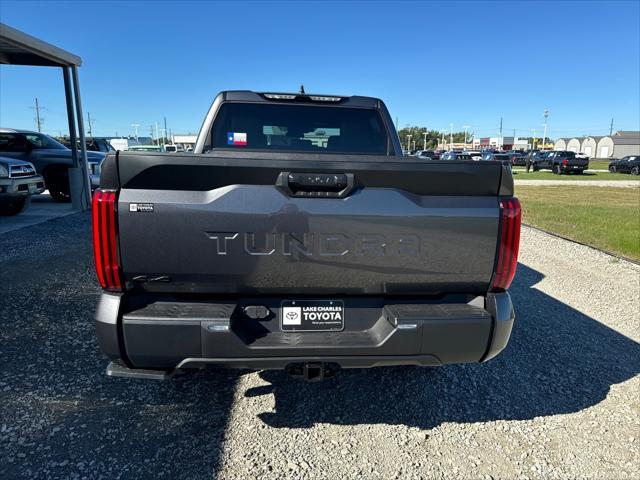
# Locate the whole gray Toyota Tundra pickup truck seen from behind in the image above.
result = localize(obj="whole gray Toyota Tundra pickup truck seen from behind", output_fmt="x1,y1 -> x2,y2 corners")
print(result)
92,91 -> 520,380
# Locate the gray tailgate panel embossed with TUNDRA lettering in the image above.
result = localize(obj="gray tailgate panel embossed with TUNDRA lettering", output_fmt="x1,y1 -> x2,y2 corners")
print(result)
111,154 -> 504,295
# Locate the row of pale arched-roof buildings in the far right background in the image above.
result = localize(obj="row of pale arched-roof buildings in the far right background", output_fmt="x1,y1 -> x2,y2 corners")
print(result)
554,130 -> 640,158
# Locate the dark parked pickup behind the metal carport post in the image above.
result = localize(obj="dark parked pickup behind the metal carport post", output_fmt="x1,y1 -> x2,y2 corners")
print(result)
0,128 -> 104,202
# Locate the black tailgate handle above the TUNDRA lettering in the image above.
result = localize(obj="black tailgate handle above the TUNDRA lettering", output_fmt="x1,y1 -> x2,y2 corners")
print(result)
277,172 -> 354,198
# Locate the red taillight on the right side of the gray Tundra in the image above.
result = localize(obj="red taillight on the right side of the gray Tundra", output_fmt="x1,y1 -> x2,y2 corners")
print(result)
491,198 -> 522,290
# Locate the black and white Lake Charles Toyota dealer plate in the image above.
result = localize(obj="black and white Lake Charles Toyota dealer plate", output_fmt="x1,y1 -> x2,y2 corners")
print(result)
280,300 -> 344,332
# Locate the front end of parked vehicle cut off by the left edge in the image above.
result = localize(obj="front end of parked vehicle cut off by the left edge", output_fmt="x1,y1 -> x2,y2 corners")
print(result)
0,157 -> 44,215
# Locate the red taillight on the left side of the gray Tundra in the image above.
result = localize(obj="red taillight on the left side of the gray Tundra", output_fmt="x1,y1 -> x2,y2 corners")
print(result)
91,190 -> 123,292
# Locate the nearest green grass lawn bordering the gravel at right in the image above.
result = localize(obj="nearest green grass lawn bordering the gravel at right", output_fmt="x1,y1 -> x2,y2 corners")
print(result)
516,185 -> 640,260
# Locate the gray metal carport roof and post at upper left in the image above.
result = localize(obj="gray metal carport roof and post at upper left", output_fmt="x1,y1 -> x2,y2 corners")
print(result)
0,23 -> 91,210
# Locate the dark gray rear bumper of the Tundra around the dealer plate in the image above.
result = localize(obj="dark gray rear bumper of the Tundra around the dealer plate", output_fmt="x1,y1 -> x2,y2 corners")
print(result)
95,292 -> 514,371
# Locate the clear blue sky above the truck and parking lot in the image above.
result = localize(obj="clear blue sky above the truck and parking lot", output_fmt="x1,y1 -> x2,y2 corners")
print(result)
0,0 -> 640,138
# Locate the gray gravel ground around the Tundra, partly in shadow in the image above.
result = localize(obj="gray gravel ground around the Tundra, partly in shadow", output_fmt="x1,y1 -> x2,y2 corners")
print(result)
0,215 -> 640,479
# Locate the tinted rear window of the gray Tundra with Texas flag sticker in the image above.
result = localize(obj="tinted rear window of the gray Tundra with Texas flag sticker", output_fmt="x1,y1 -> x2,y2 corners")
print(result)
211,103 -> 387,155
